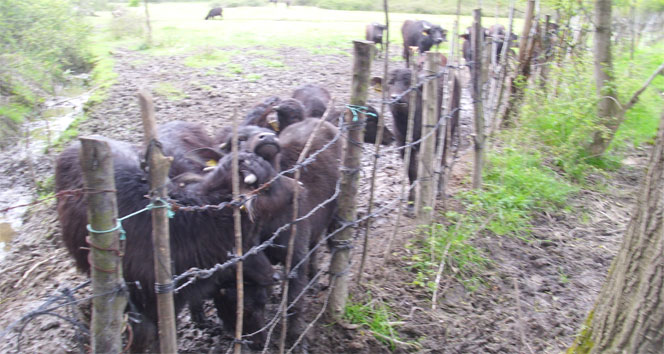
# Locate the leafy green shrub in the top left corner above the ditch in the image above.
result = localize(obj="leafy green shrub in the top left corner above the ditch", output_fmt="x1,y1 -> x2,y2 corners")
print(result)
0,0 -> 91,129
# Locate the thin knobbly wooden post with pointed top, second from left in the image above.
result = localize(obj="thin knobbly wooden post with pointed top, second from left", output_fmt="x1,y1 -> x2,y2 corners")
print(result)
138,90 -> 178,353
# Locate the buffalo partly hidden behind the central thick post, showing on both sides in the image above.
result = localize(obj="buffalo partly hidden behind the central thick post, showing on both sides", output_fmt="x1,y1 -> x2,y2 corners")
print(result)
293,84 -> 394,145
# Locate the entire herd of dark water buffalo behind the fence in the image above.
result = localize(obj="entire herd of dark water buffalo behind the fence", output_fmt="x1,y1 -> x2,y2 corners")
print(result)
55,15 -> 466,352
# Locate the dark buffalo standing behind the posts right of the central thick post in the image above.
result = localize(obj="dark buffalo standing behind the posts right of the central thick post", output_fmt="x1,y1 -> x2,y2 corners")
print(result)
373,60 -> 460,200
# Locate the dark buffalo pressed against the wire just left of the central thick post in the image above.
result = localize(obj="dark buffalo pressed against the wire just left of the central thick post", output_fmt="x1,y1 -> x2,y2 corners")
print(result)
211,118 -> 341,343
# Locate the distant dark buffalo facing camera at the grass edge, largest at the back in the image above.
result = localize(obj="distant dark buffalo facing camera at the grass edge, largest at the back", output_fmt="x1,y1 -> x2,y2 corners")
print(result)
401,20 -> 447,67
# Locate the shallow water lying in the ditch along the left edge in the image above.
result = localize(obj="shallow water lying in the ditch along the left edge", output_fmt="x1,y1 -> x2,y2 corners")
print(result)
0,81 -> 91,261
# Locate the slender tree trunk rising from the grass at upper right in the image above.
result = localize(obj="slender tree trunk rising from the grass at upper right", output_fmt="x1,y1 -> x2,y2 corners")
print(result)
587,0 -> 621,156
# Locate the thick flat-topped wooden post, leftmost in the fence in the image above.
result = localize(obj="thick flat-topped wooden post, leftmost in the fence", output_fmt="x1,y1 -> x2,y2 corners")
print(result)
80,138 -> 127,353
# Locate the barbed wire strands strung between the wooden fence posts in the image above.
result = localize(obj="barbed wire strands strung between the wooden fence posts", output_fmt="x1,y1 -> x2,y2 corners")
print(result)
0,5 -> 536,352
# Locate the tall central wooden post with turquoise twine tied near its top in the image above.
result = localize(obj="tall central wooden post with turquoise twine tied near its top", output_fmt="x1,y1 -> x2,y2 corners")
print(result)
327,41 -> 374,319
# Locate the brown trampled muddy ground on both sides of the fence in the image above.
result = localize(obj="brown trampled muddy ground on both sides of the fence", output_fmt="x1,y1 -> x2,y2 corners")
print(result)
0,42 -> 646,353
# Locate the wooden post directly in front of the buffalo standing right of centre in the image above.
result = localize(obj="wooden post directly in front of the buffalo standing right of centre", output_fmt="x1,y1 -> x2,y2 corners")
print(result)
415,52 -> 443,224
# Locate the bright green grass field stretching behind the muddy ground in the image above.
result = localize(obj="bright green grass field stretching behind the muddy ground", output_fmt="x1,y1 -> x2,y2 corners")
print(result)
93,3 -> 522,54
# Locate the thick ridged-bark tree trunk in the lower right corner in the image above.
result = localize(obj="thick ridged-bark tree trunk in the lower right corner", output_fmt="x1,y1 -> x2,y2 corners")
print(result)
568,110 -> 664,353
